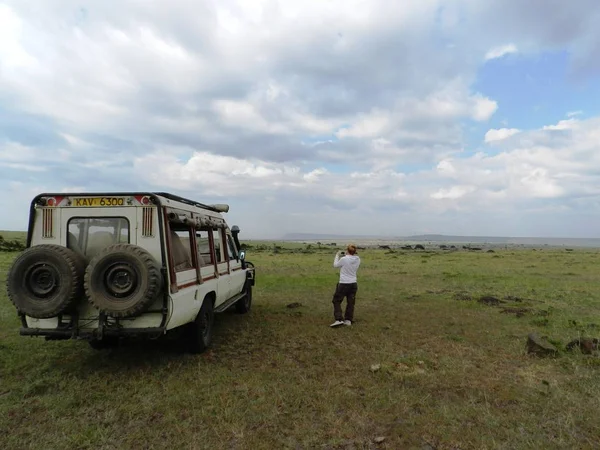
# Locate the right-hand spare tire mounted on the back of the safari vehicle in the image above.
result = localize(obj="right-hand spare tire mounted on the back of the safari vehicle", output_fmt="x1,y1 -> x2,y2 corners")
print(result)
84,244 -> 163,317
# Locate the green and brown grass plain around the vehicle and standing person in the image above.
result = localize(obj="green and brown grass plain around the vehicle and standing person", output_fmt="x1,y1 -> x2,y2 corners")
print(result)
0,249 -> 600,449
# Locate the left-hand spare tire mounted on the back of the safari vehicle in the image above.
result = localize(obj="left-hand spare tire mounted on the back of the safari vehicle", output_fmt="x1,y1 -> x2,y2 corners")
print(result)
6,244 -> 85,319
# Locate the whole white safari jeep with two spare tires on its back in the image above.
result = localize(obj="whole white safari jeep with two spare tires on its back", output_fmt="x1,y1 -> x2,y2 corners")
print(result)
7,193 -> 255,353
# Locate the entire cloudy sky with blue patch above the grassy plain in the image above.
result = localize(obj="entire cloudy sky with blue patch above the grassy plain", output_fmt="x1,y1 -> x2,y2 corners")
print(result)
0,0 -> 600,238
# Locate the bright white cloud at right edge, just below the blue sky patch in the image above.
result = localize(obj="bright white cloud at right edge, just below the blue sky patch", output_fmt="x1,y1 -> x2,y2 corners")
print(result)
426,118 -> 600,208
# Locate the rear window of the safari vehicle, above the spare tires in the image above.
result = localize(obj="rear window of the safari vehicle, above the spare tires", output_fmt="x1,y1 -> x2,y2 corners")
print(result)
67,217 -> 129,258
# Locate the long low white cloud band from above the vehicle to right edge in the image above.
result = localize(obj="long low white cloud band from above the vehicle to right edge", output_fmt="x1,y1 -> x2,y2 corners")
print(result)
135,115 -> 600,210
